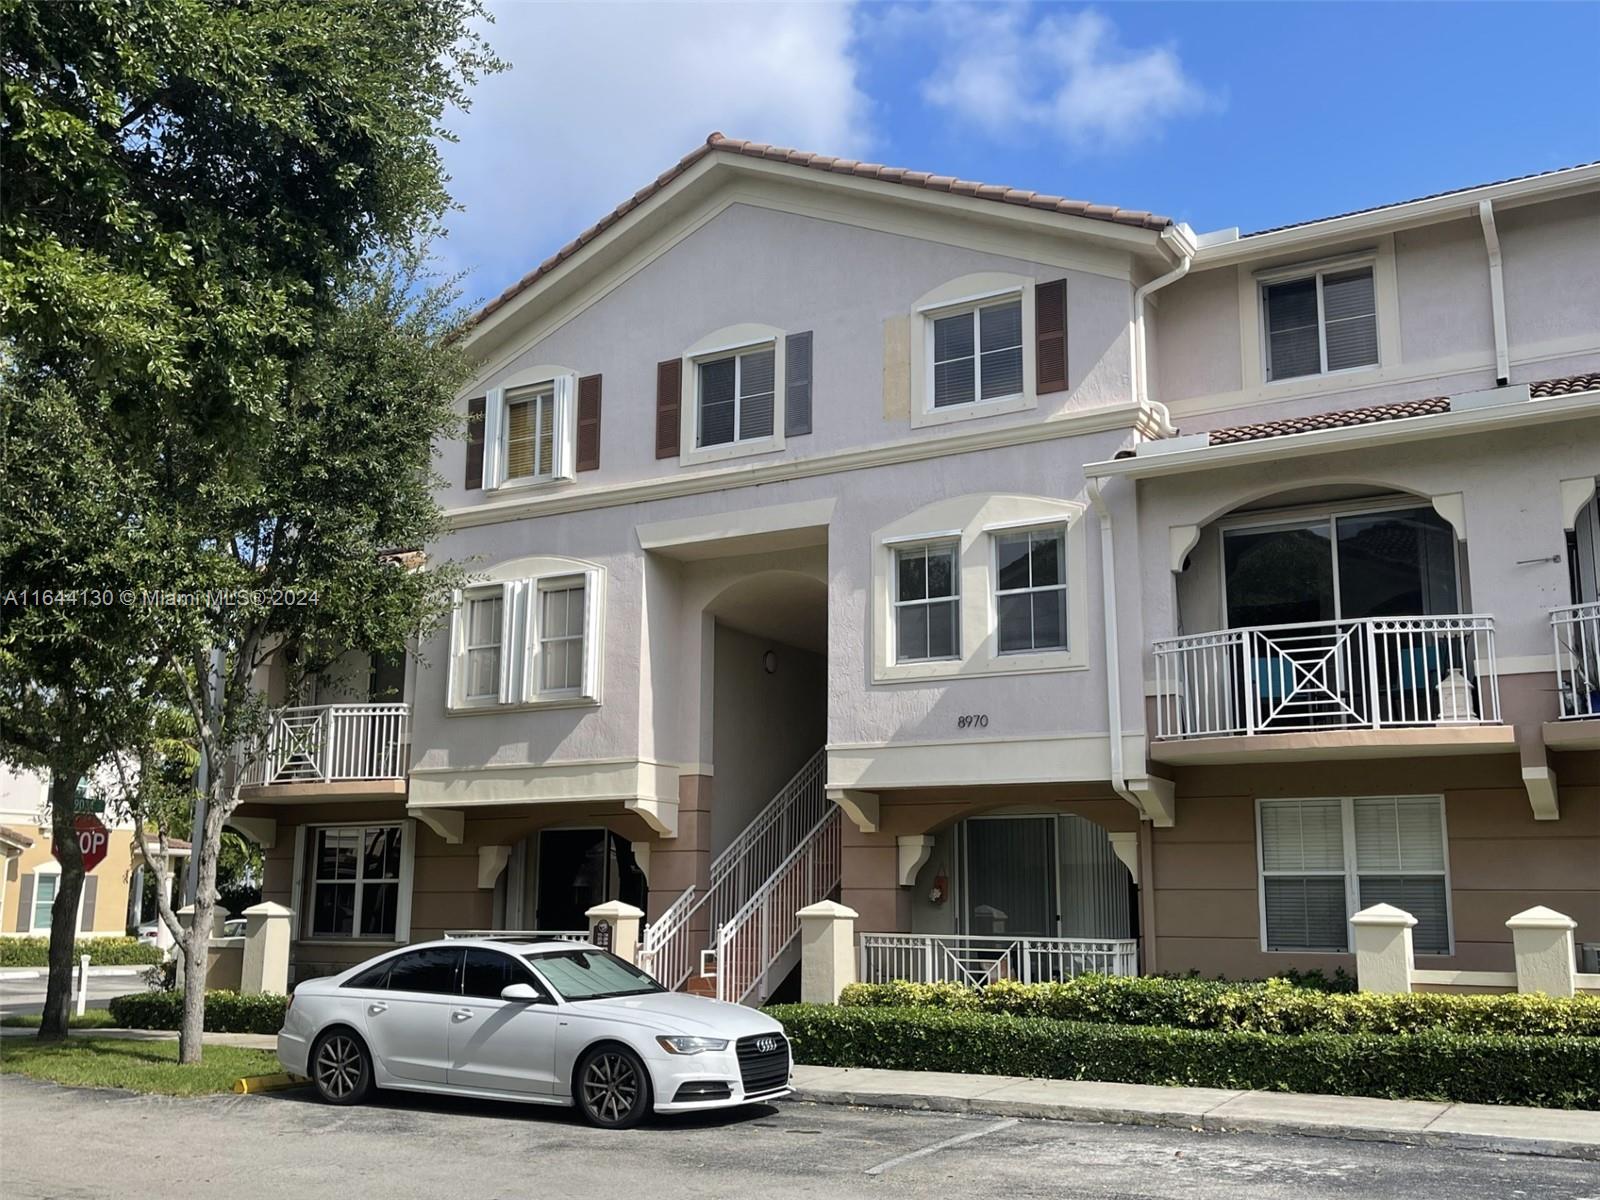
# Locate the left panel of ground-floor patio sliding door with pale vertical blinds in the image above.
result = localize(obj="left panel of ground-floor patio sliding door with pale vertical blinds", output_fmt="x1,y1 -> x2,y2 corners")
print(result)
965,816 -> 1061,938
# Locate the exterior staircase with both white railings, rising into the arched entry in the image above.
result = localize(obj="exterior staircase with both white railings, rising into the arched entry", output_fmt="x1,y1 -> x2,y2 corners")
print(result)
638,750 -> 840,1005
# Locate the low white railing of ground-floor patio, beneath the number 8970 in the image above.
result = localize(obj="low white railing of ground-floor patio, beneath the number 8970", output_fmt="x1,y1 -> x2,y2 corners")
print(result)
859,933 -> 1139,987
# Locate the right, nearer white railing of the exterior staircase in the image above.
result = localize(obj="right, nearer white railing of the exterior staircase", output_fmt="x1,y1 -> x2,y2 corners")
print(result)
717,806 -> 842,1003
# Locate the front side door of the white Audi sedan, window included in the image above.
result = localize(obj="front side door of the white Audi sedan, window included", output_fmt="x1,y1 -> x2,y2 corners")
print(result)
450,946 -> 560,1096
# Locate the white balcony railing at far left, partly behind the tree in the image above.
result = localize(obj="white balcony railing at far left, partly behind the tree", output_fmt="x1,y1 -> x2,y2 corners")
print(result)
243,704 -> 411,787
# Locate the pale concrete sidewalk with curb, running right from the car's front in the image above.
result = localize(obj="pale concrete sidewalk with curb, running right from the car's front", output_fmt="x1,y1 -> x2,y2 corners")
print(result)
794,1067 -> 1600,1162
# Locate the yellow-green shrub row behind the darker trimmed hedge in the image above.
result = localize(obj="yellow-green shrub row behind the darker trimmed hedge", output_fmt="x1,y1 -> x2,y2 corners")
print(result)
840,974 -> 1600,1037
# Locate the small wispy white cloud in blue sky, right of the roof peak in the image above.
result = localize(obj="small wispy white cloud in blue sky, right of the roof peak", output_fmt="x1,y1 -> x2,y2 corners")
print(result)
896,5 -> 1216,149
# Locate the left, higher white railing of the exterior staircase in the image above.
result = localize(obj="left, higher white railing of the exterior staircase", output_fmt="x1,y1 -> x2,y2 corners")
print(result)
638,750 -> 830,989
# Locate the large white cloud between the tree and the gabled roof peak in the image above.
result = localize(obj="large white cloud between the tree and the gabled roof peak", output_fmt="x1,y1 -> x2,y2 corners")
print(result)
440,2 -> 869,294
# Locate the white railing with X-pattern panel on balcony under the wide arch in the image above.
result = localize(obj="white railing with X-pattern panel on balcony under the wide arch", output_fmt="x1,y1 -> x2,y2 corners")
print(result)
1154,616 -> 1499,738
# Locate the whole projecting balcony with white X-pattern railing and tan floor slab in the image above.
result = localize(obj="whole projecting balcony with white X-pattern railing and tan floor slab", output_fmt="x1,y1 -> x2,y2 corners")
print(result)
1150,614 -> 1515,763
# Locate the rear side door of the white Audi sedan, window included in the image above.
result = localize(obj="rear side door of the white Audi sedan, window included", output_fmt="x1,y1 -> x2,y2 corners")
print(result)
363,946 -> 461,1083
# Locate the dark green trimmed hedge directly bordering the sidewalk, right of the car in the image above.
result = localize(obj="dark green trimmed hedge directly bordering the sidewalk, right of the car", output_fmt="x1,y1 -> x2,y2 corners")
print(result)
766,1005 -> 1600,1109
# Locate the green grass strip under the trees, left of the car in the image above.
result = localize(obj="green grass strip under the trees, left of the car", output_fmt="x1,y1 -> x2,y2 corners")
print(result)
0,1037 -> 282,1096
